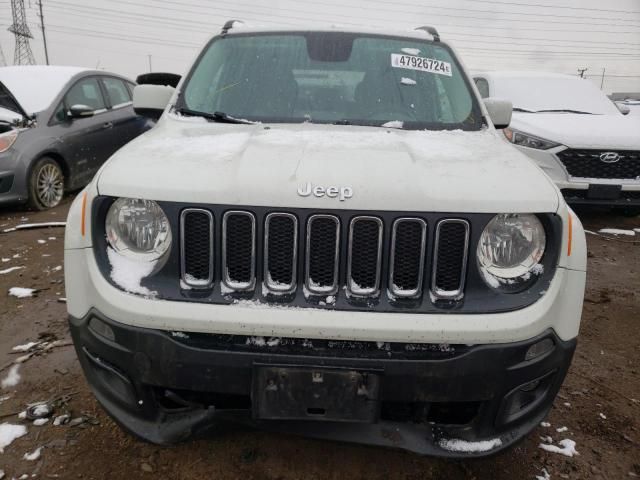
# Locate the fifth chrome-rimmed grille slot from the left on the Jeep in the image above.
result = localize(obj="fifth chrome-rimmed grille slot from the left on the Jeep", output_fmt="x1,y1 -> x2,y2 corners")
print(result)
347,217 -> 382,296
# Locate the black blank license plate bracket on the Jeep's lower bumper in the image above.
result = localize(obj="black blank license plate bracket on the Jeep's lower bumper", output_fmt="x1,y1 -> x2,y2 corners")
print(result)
252,364 -> 380,423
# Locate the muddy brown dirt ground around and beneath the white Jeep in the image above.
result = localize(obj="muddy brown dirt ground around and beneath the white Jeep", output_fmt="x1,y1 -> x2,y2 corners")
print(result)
0,200 -> 640,480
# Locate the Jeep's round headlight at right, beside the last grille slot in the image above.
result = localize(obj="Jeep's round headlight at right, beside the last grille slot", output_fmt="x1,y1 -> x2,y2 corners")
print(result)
477,213 -> 546,288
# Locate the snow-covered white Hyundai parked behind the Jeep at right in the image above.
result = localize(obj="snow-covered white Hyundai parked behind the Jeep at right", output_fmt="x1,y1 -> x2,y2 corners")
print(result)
474,72 -> 640,213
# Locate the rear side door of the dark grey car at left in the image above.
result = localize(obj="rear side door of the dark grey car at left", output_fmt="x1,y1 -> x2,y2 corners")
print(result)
100,76 -> 148,158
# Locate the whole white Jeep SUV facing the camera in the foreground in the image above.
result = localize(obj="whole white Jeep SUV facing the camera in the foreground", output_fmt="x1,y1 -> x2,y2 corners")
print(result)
65,22 -> 586,456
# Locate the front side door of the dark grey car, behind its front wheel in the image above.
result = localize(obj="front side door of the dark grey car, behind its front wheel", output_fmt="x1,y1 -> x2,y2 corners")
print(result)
58,77 -> 111,184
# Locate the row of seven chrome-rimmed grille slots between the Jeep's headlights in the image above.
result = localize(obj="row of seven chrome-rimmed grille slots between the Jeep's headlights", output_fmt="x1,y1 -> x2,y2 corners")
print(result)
180,209 -> 470,300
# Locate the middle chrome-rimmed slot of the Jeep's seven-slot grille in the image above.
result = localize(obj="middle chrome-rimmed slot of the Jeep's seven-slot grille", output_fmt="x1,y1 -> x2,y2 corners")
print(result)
305,215 -> 340,295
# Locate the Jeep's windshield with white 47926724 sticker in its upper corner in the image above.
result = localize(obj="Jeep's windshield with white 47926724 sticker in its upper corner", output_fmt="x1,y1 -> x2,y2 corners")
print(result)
177,32 -> 482,130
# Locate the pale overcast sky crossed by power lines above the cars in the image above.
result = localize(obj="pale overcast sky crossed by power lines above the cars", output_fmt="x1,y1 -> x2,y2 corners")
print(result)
0,0 -> 640,92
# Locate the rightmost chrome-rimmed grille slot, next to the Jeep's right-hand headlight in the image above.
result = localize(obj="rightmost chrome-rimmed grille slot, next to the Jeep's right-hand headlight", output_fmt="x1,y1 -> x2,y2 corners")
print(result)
431,219 -> 469,300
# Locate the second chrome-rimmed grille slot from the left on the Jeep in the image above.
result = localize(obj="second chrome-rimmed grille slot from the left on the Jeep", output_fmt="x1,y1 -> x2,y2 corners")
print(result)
222,211 -> 256,290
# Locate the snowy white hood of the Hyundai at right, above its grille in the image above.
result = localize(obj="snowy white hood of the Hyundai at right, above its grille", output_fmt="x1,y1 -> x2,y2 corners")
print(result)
510,111 -> 640,150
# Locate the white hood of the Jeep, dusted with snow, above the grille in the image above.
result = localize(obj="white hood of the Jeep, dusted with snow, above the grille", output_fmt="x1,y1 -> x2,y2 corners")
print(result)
97,115 -> 559,213
